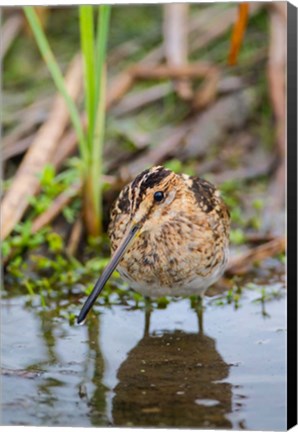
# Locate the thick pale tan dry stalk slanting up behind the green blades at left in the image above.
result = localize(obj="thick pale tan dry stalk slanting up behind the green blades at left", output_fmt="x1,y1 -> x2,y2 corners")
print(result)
1,56 -> 82,239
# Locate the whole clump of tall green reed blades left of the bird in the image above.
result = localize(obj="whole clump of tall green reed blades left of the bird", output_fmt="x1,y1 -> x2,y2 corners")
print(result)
24,5 -> 111,236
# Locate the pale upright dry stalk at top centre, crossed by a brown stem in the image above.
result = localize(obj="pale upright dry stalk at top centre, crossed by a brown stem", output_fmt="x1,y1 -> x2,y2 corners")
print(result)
163,3 -> 193,100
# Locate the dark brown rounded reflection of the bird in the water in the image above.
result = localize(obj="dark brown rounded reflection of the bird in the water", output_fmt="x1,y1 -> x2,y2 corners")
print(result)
112,330 -> 232,428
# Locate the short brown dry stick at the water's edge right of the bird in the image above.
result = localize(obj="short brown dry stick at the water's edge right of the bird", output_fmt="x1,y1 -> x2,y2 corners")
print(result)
226,237 -> 286,274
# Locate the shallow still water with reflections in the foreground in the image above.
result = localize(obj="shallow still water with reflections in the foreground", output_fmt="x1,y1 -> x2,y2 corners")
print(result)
1,266 -> 286,430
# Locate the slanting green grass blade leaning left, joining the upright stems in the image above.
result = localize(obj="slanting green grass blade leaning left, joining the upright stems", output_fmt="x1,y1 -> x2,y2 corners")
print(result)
24,6 -> 87,165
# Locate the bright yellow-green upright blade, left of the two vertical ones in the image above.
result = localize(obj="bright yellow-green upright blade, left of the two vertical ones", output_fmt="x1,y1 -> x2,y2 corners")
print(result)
79,5 -> 96,150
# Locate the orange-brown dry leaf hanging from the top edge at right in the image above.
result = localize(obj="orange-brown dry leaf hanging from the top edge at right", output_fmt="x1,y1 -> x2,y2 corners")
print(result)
228,2 -> 249,66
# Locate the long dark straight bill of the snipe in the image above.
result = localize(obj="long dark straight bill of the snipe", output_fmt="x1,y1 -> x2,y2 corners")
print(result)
77,225 -> 139,324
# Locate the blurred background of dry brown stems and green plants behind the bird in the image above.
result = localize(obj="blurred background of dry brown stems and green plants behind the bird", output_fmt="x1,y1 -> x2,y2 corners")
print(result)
1,3 -> 286,314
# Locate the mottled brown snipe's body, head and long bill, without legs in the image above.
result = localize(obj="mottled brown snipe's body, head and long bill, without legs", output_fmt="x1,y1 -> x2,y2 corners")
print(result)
78,166 -> 230,322
